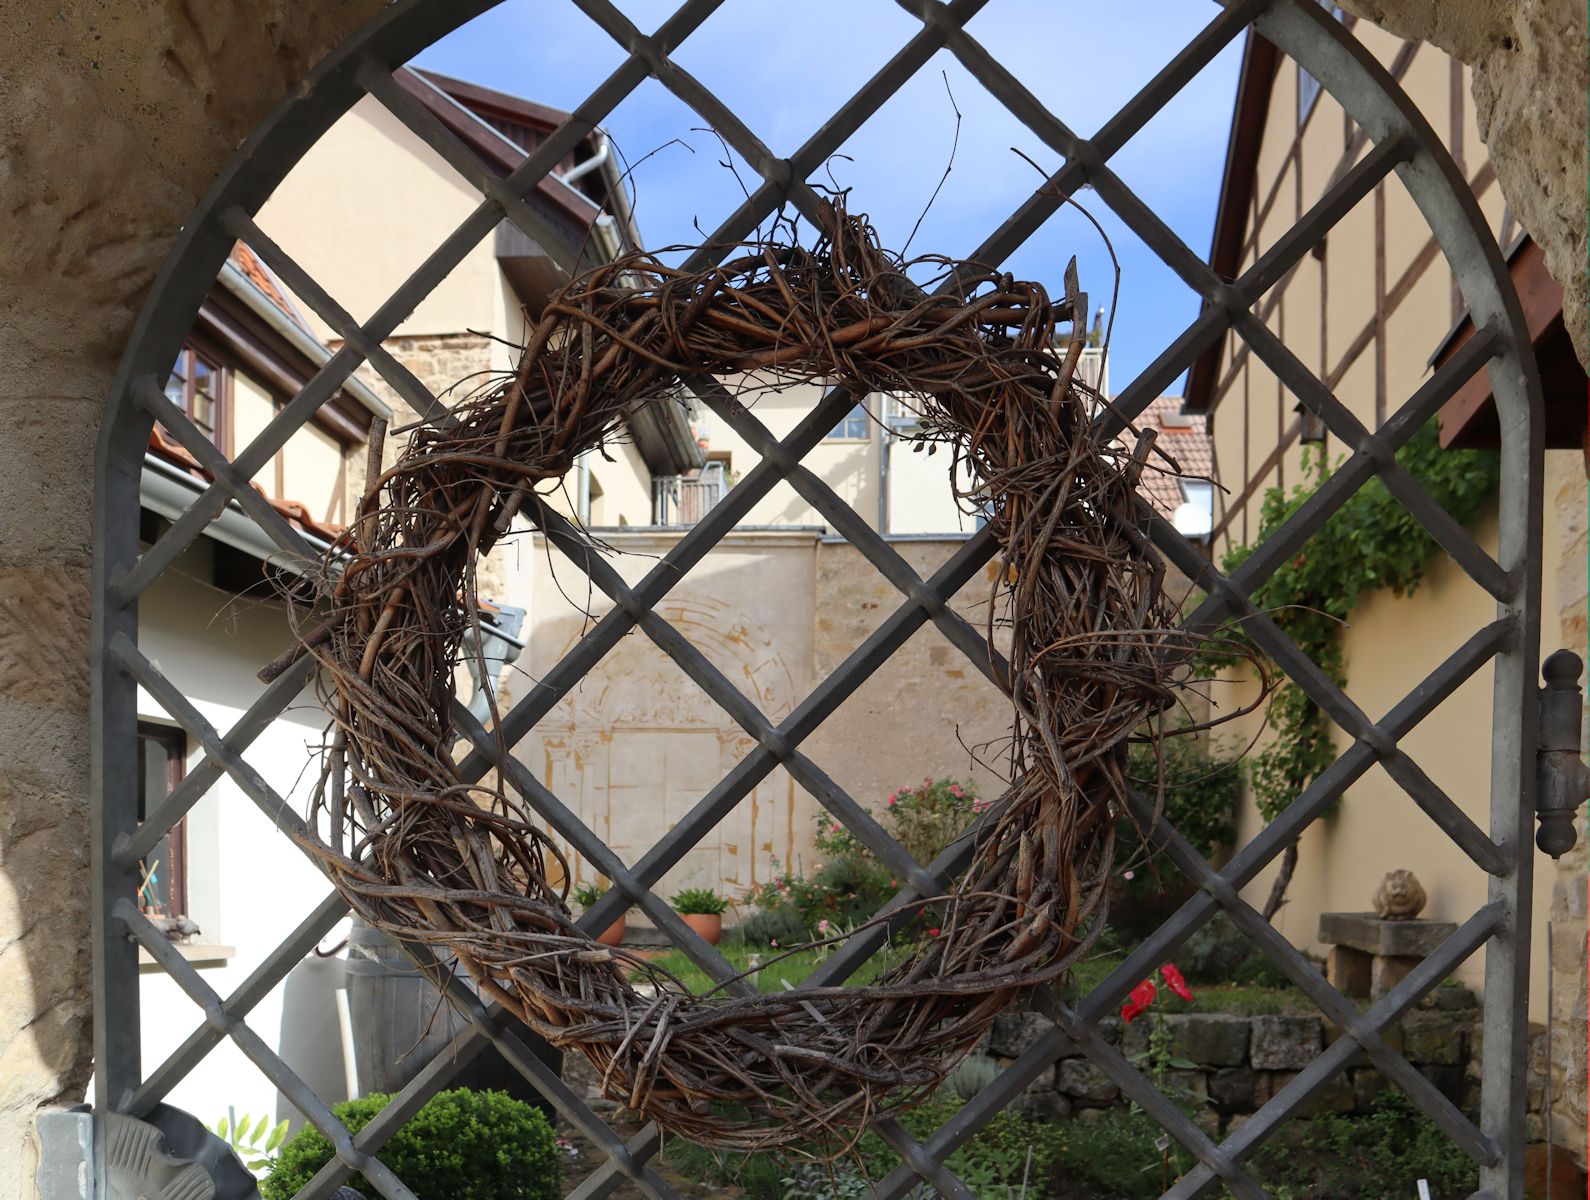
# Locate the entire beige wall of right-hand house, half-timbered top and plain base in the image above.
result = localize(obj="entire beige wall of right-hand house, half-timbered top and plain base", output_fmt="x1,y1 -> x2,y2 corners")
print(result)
1212,22 -> 1585,1155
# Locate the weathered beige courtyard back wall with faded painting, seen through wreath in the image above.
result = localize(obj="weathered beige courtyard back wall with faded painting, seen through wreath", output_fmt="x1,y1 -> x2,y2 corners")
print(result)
521,528 -> 1010,900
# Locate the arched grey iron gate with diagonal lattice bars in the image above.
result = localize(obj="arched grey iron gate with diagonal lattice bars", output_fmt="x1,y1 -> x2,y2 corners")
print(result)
92,0 -> 1542,1200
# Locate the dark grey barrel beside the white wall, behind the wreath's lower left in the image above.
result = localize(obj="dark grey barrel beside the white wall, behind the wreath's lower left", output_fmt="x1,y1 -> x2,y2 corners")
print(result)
347,917 -> 561,1119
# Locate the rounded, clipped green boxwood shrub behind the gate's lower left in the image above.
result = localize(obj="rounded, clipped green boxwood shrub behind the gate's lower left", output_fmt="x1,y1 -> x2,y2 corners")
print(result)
261,1087 -> 563,1200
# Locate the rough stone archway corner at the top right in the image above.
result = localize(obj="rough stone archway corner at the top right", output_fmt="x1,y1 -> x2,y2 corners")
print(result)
1342,0 -> 1590,362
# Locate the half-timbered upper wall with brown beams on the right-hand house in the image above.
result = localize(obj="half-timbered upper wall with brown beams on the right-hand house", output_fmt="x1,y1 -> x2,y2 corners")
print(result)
1210,22 -> 1523,540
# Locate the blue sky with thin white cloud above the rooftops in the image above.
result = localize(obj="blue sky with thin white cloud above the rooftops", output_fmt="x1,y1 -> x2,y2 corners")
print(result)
417,0 -> 1240,389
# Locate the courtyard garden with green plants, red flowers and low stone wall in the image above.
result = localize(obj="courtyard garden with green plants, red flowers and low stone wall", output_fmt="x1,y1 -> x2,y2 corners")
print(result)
540,756 -> 1479,1200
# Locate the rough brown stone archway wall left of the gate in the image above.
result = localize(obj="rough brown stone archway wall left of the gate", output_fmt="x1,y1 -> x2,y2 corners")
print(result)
0,0 -> 382,1200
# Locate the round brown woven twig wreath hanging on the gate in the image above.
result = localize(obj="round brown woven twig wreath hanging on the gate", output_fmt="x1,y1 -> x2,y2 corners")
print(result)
304,208 -> 1172,1149
